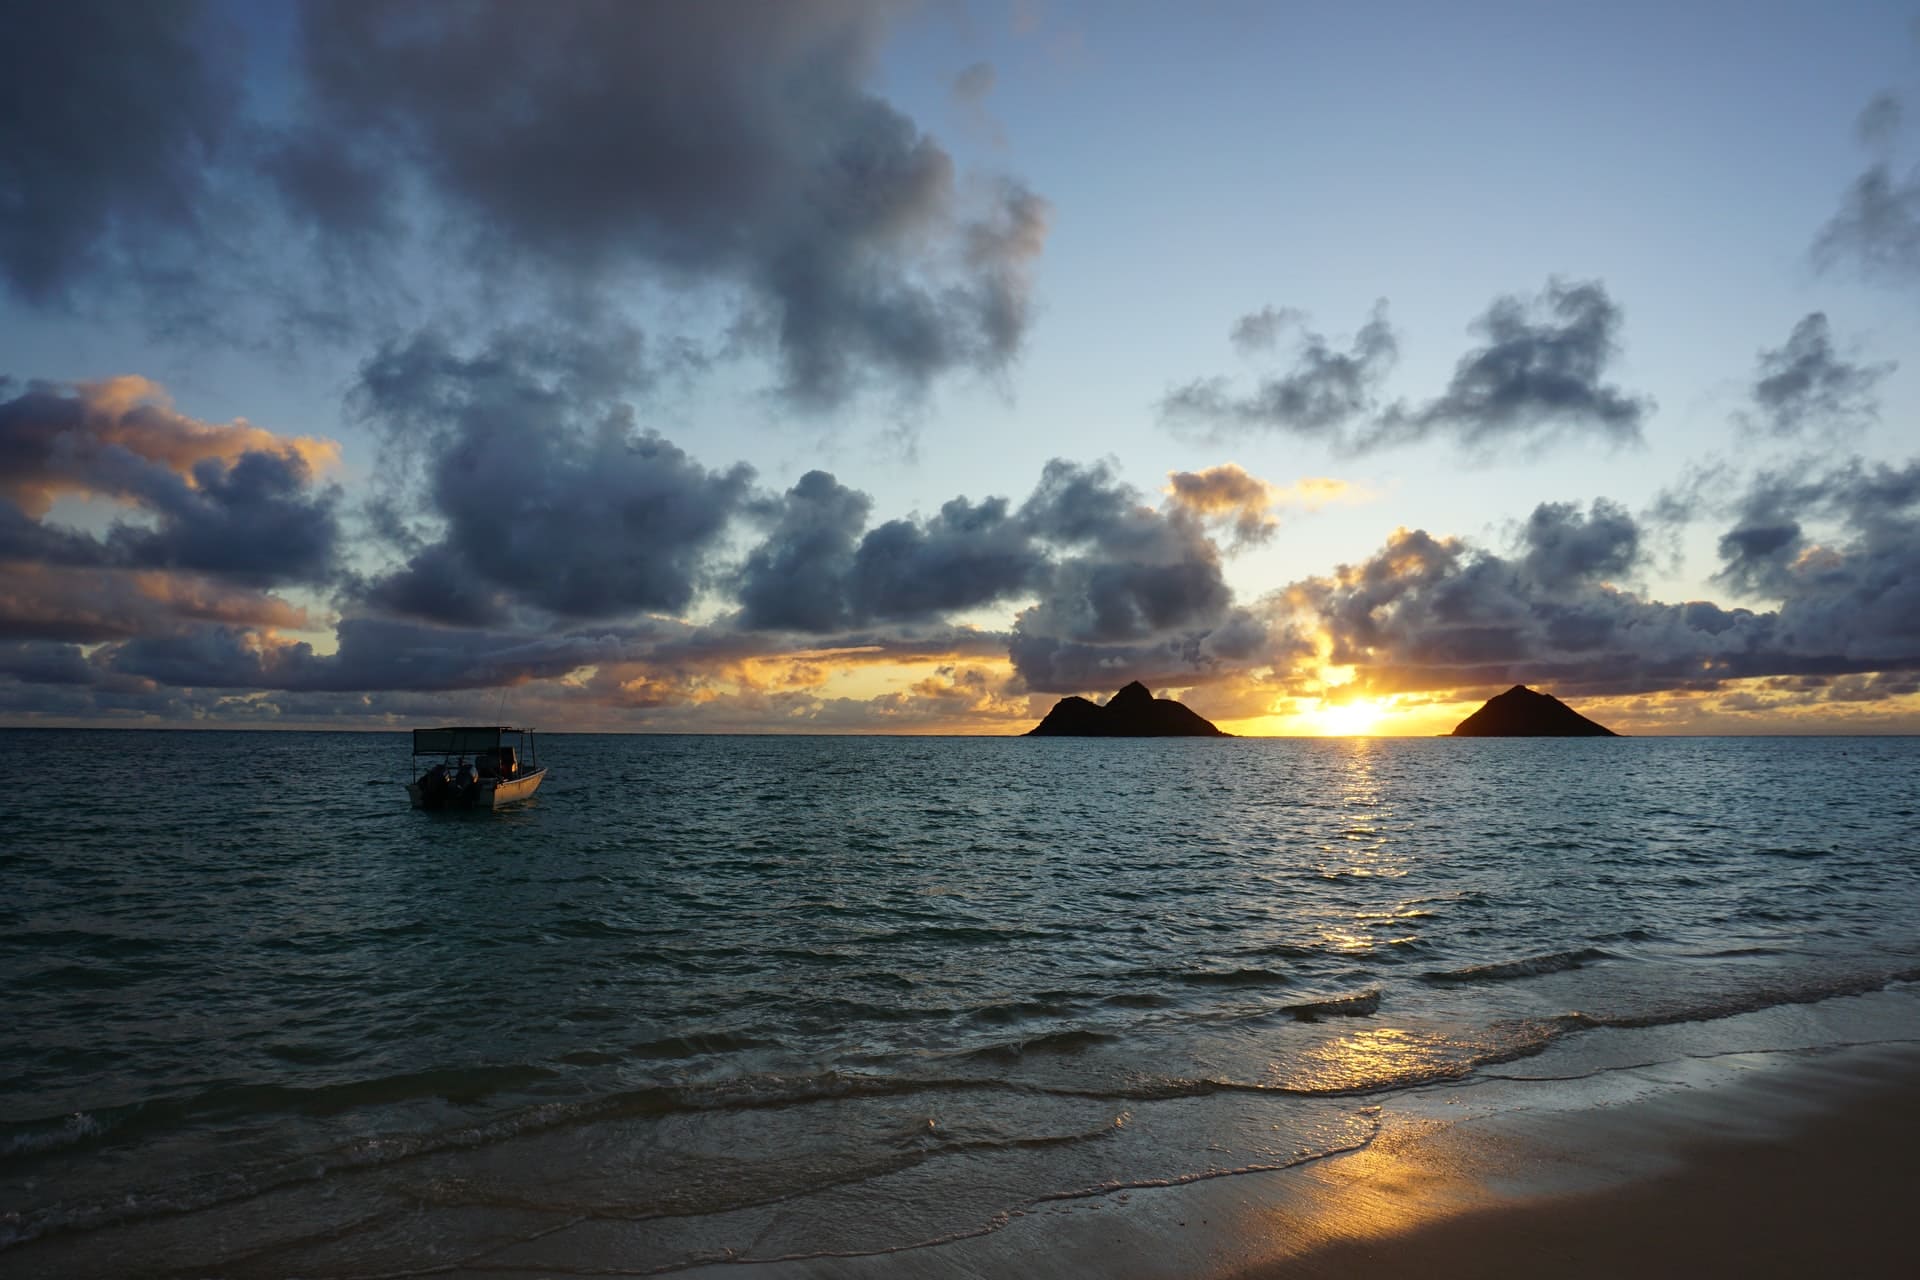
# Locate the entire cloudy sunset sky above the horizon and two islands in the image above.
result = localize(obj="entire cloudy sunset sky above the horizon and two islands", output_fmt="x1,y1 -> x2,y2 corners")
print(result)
0,0 -> 1920,735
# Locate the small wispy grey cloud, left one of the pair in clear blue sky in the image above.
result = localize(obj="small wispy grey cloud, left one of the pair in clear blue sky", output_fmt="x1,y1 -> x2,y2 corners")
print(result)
1160,301 -> 1400,441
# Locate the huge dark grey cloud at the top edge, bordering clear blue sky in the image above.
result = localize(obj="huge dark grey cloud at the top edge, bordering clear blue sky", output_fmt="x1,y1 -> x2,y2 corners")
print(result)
273,0 -> 1046,405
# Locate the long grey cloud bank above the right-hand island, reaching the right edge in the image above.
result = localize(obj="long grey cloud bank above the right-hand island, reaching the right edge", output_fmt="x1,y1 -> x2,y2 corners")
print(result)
1290,475 -> 1920,695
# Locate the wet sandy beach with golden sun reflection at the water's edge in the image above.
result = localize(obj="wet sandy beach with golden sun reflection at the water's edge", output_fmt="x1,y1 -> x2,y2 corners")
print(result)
660,1040 -> 1920,1280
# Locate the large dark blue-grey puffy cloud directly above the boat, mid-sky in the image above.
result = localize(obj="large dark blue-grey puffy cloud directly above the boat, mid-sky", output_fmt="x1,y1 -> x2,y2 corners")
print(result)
355,332 -> 753,624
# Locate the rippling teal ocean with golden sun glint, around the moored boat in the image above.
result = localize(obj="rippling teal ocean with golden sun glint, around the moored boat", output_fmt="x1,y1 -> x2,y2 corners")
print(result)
0,729 -> 1920,1278
